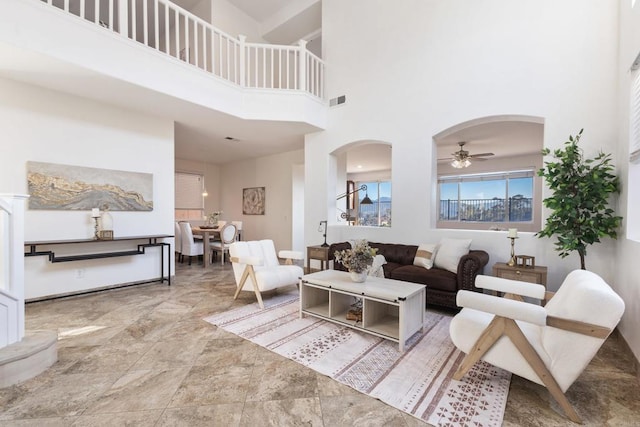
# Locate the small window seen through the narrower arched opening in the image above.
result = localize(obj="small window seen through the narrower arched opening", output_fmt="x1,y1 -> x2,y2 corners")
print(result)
356,181 -> 391,227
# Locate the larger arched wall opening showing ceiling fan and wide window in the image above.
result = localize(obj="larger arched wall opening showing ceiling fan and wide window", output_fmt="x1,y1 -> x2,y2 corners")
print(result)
432,115 -> 544,232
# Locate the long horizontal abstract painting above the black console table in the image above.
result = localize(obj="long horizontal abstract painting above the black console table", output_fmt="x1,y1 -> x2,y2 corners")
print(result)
27,162 -> 153,211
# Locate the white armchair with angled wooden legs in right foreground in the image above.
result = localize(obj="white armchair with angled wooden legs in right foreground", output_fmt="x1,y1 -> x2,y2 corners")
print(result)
449,270 -> 624,423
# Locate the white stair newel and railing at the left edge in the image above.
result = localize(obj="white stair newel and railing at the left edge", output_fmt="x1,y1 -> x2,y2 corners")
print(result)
0,194 -> 28,348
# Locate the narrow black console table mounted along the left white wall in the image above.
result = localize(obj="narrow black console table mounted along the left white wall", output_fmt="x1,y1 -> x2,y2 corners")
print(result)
24,234 -> 173,286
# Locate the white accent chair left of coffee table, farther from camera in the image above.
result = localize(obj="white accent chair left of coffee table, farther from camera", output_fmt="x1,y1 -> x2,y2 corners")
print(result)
229,240 -> 303,308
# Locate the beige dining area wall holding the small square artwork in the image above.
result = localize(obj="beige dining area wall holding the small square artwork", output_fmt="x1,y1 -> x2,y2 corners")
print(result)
221,150 -> 304,250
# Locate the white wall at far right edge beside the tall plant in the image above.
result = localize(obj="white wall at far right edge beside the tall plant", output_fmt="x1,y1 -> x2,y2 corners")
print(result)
616,0 -> 640,368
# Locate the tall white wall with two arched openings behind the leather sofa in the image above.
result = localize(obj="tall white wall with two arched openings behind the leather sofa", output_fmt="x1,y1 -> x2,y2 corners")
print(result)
305,0 -> 618,300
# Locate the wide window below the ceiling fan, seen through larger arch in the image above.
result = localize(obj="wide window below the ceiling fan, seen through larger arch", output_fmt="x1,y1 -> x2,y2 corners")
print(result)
438,169 -> 535,223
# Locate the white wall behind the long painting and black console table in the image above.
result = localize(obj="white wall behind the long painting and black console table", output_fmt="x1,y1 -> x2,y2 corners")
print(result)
0,79 -> 174,299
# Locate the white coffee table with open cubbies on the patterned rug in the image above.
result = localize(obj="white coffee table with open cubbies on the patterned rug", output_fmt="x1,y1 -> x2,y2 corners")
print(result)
300,270 -> 427,351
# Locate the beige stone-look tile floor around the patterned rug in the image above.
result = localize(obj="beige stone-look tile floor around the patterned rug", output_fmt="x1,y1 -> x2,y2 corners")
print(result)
0,263 -> 640,426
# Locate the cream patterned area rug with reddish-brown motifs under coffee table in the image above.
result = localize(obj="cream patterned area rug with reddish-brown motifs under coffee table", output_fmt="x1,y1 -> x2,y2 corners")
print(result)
204,291 -> 511,426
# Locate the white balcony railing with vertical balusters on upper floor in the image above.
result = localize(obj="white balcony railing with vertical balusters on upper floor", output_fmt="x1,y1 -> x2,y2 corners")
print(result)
41,0 -> 324,99
